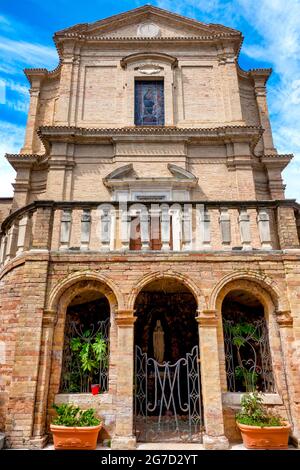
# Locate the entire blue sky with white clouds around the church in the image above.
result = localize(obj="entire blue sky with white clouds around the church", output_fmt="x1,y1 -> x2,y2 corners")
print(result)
0,0 -> 300,201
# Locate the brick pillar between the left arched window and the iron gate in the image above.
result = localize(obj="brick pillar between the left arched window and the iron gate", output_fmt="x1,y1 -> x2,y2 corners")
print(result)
112,310 -> 136,450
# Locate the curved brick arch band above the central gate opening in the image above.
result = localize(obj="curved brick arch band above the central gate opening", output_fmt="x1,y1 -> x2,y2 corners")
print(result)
128,271 -> 206,310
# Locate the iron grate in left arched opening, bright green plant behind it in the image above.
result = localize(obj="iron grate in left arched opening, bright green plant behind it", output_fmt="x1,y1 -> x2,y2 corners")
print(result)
60,317 -> 110,393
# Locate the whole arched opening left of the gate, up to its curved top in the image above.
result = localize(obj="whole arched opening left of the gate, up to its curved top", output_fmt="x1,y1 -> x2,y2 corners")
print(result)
60,291 -> 110,393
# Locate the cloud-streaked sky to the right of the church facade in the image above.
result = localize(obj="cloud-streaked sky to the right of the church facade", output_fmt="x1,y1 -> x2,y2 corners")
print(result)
156,0 -> 300,201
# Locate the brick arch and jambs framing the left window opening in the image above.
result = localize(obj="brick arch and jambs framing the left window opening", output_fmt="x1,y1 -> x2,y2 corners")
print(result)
33,272 -> 122,442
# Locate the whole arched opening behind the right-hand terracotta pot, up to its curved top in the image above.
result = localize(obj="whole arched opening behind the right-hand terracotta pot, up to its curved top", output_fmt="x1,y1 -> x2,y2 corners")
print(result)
222,290 -> 274,392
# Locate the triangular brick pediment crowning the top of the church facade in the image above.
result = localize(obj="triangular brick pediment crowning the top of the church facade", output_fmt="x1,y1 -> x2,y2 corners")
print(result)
58,5 -> 238,37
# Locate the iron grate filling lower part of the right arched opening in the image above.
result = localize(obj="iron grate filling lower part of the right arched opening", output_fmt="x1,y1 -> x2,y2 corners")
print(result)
223,318 -> 275,393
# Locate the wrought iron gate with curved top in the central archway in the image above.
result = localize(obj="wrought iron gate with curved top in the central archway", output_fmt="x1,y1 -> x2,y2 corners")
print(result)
135,346 -> 203,442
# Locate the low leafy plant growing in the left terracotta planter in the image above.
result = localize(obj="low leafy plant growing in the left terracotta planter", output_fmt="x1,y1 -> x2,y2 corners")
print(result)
52,403 -> 101,427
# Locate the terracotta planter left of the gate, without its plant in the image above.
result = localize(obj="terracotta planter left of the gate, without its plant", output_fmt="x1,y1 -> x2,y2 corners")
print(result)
50,423 -> 102,450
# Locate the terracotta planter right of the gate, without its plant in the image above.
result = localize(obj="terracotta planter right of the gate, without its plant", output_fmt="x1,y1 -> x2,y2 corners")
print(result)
236,422 -> 291,449
